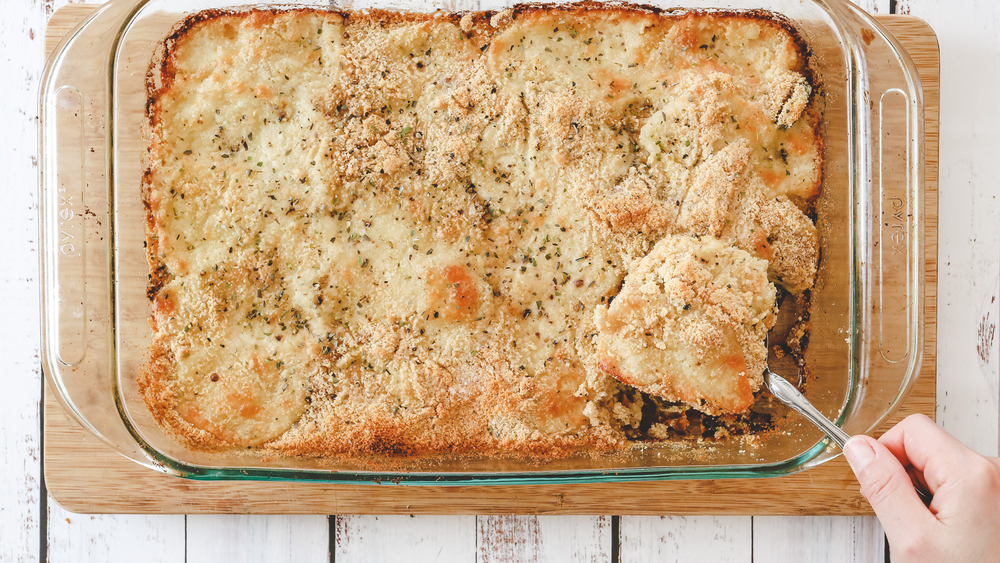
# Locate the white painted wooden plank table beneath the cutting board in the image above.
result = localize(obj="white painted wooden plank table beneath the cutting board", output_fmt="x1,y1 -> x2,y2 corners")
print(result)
0,0 -> 1000,562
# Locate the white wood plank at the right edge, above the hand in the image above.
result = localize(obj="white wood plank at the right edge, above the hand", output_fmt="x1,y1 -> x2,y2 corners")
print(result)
905,0 -> 1000,455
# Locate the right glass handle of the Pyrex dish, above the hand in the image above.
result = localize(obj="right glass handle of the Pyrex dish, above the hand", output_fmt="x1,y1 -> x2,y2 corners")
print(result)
842,2 -> 925,433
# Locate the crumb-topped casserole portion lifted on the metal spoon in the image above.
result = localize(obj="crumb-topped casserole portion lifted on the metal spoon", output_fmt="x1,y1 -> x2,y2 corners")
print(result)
596,235 -> 775,414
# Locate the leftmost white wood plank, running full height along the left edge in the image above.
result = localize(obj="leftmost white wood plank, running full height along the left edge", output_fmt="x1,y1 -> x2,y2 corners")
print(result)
0,1 -> 73,562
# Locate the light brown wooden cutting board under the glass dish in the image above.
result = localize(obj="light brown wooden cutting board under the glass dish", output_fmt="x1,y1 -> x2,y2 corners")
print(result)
43,5 -> 940,515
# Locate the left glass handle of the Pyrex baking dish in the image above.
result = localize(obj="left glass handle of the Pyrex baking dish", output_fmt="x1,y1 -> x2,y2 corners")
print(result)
39,2 -> 160,472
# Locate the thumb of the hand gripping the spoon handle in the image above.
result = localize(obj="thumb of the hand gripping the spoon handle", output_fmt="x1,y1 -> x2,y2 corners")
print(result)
844,435 -> 934,540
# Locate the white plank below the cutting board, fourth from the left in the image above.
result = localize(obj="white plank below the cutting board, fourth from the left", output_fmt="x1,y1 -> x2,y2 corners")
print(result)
334,516 -> 476,563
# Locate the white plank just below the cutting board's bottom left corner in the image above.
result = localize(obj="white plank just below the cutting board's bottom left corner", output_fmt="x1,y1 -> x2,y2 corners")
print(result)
48,512 -> 187,563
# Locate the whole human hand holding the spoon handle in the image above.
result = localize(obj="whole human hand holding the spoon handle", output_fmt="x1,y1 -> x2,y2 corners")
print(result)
844,415 -> 1000,562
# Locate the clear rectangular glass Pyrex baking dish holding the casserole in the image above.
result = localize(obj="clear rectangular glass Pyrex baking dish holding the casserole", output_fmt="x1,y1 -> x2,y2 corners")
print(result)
41,0 -> 924,485
